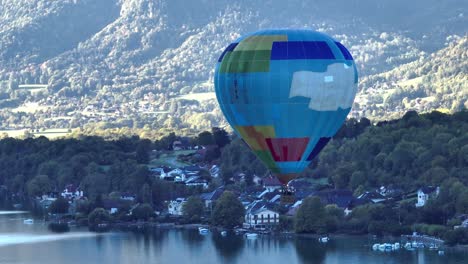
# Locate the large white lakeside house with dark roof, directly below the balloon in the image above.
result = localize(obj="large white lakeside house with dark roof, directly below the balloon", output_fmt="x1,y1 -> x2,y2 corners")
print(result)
244,201 -> 280,229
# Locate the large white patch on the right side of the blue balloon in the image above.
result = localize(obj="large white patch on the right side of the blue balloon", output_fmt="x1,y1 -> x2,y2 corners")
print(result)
289,63 -> 357,111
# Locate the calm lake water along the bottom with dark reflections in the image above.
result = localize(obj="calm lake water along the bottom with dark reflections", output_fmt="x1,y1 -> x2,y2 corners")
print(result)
0,212 -> 468,264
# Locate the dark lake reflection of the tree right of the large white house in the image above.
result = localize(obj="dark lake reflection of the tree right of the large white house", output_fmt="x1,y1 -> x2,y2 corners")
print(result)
294,237 -> 328,264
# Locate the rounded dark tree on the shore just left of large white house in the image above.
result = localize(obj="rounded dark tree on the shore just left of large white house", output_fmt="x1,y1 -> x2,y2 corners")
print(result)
211,191 -> 245,228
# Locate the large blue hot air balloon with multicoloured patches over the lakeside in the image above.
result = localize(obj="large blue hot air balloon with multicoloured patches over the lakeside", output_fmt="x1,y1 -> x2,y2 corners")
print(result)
214,29 -> 358,192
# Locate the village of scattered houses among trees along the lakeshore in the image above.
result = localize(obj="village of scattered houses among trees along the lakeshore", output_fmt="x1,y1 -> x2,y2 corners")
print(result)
29,140 -> 468,237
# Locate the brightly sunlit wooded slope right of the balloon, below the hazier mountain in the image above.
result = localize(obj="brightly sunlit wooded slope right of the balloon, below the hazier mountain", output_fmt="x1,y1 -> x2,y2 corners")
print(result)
353,35 -> 468,118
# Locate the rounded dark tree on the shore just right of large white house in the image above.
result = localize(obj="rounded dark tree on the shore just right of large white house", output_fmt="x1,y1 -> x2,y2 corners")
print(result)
294,196 -> 326,233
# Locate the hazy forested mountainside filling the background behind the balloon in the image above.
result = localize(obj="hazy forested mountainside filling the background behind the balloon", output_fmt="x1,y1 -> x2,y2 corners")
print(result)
0,0 -> 468,138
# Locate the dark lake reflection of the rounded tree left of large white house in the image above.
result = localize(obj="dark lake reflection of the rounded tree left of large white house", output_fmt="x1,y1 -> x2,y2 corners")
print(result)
211,234 -> 245,263
